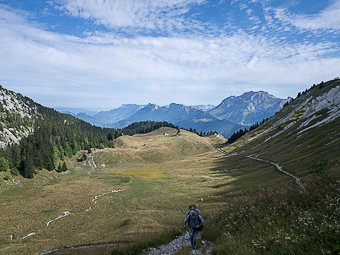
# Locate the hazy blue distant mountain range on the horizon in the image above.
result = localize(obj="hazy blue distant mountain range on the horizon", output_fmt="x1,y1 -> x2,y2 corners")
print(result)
56,91 -> 290,137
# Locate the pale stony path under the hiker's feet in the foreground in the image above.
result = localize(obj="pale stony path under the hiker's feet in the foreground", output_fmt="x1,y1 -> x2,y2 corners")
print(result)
142,231 -> 213,255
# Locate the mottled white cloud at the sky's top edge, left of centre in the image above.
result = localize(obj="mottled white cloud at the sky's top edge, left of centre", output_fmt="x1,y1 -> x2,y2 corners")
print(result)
50,0 -> 204,30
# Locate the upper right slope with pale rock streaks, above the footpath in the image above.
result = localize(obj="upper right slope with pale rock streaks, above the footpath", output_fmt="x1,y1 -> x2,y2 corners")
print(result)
225,79 -> 340,176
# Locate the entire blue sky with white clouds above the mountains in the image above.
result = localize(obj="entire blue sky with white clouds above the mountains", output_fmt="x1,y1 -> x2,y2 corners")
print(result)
0,0 -> 340,110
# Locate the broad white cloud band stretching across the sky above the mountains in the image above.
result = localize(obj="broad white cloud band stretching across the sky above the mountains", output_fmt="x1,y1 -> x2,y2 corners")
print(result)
0,5 -> 340,108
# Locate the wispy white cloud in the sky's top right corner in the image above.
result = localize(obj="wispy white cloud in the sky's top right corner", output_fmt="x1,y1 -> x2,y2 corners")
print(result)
274,0 -> 340,32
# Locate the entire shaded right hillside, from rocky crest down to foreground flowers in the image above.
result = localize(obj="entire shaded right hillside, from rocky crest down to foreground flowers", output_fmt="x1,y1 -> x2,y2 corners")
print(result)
199,79 -> 340,255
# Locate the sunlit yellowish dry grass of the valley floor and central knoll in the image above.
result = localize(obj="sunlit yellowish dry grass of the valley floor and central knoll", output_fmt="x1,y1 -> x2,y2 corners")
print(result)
0,128 -> 233,254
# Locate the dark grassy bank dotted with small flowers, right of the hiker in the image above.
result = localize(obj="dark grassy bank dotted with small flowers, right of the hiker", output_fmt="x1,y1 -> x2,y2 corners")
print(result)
204,175 -> 340,254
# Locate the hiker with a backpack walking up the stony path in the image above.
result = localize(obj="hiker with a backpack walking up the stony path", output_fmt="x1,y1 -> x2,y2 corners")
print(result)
184,205 -> 204,249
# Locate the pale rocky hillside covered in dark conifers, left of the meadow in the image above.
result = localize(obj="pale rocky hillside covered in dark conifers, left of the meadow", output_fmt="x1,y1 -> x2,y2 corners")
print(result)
0,87 -> 169,179
